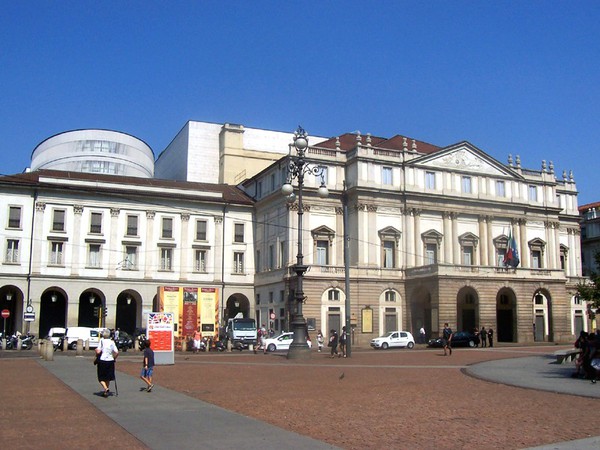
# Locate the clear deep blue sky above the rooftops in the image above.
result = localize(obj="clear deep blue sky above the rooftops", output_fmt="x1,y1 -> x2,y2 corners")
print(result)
0,0 -> 600,204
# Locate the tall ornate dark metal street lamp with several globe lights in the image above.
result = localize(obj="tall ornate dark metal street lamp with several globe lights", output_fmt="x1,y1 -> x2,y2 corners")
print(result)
281,127 -> 329,359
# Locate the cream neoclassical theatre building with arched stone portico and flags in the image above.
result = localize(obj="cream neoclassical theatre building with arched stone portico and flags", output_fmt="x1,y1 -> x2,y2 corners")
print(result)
243,134 -> 588,345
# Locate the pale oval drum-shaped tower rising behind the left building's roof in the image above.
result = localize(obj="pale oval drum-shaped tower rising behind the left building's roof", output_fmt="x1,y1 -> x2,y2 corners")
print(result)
31,129 -> 154,178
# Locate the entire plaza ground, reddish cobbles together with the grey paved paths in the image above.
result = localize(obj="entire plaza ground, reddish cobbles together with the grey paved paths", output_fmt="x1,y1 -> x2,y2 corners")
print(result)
0,346 -> 600,450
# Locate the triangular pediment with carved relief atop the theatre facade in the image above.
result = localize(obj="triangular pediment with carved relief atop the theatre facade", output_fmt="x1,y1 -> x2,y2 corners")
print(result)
412,142 -> 520,178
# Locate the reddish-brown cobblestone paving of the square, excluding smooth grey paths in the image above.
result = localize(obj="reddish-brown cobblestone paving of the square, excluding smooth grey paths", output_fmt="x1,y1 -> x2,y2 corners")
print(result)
0,346 -> 600,449
